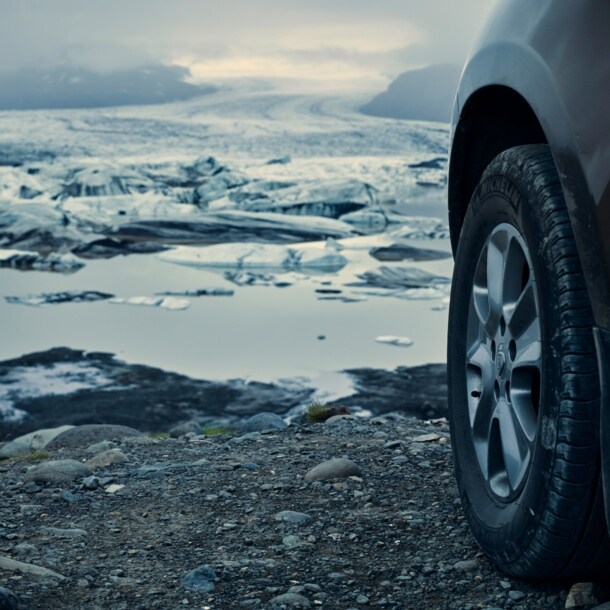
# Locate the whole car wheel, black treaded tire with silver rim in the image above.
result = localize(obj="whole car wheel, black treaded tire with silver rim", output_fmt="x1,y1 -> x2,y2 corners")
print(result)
448,145 -> 610,579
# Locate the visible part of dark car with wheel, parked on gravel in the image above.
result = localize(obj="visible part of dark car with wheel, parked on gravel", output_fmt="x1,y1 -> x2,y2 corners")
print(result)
448,0 -> 610,580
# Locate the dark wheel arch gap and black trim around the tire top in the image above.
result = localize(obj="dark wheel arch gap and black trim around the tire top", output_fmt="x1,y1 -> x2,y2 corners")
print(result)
448,82 -> 610,329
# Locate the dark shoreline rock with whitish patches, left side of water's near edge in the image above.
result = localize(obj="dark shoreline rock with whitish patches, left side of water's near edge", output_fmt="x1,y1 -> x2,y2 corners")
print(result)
0,348 -> 315,436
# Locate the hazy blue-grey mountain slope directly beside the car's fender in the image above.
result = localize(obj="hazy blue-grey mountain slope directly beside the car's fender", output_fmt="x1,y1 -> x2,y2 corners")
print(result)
360,64 -> 461,123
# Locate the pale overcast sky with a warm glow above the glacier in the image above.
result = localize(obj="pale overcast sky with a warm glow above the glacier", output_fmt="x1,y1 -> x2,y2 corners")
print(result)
0,0 -> 493,81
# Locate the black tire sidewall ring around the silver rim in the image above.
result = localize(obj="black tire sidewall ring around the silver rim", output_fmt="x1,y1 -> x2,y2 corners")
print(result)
448,162 -> 561,565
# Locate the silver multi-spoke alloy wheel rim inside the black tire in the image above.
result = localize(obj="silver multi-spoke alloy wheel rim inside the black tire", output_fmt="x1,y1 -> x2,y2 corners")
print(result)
466,223 -> 542,501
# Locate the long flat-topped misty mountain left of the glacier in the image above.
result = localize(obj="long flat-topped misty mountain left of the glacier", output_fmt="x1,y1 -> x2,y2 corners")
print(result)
0,64 -> 215,110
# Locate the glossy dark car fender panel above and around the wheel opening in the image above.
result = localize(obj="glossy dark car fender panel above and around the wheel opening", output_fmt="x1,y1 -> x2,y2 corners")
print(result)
450,0 -> 610,329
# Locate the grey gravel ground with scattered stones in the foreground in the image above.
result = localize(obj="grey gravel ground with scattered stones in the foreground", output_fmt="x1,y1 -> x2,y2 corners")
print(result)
0,414 -> 610,610
